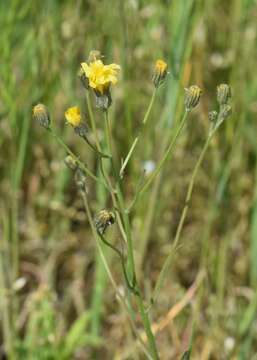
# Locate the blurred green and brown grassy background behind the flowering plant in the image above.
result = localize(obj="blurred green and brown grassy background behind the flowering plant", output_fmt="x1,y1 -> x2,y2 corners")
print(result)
0,0 -> 257,360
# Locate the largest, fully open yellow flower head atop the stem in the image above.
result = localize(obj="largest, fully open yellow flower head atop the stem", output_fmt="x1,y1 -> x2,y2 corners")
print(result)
81,60 -> 120,94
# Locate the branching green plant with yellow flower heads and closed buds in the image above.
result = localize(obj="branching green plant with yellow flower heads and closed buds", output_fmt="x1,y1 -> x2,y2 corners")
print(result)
33,50 -> 231,360
